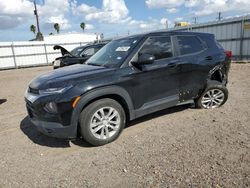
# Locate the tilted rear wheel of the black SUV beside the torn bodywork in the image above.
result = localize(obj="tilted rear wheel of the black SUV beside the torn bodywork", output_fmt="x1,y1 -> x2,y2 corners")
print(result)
195,81 -> 228,109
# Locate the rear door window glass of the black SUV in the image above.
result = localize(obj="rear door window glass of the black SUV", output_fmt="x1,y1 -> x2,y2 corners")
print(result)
177,36 -> 203,55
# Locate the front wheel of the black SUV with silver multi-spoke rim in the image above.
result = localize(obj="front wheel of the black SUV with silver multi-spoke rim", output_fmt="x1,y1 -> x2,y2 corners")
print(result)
79,98 -> 126,146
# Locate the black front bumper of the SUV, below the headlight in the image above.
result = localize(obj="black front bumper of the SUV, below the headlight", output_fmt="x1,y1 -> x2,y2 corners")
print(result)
25,89 -> 77,139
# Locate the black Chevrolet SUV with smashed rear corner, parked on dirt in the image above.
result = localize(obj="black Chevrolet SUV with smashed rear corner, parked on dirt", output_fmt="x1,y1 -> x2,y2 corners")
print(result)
25,32 -> 231,145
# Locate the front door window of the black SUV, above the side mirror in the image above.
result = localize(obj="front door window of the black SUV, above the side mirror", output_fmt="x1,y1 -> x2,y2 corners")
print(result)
139,37 -> 173,60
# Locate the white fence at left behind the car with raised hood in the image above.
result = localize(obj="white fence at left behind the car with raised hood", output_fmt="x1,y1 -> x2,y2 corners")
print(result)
0,41 -> 89,70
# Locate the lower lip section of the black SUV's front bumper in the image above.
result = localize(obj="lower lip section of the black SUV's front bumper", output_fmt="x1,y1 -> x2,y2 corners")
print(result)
30,118 -> 77,139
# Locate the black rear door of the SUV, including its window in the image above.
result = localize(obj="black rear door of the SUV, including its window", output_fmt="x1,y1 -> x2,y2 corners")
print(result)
174,35 -> 208,102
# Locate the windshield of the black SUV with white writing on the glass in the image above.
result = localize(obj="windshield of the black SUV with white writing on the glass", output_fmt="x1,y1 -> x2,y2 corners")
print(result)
86,37 -> 141,67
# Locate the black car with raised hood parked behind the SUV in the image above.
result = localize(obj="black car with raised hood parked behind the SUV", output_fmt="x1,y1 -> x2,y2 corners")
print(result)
52,42 -> 108,69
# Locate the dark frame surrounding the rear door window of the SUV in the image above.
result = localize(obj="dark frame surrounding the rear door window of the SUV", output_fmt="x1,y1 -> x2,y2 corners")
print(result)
173,34 -> 208,57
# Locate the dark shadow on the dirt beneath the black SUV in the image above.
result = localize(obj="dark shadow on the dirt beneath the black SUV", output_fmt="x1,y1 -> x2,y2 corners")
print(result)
20,104 -> 191,148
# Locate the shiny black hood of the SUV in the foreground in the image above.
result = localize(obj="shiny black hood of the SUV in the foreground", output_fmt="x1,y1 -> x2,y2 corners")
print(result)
29,64 -> 114,89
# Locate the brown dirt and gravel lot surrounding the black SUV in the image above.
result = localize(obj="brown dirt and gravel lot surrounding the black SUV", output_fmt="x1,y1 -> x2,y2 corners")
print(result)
0,64 -> 250,188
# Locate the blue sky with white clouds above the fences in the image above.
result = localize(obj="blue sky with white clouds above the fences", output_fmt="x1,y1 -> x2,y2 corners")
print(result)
0,0 -> 250,41
